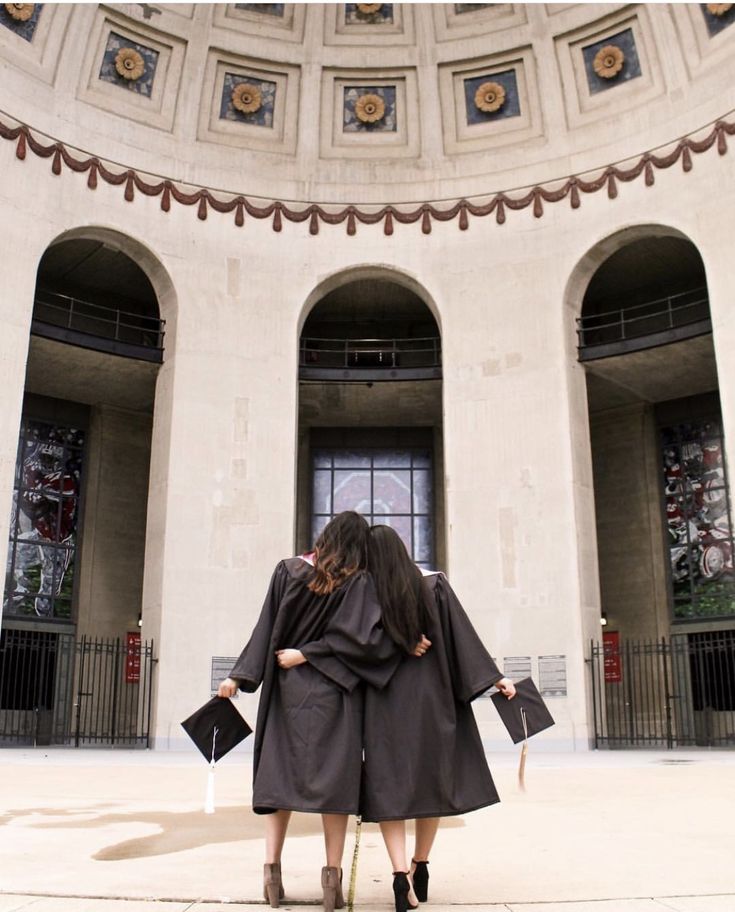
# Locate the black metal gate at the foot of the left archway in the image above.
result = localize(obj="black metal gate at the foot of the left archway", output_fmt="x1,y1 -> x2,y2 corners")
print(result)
0,629 -> 156,747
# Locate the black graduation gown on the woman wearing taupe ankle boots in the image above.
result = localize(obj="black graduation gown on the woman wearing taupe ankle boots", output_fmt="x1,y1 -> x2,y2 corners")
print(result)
230,558 -> 400,814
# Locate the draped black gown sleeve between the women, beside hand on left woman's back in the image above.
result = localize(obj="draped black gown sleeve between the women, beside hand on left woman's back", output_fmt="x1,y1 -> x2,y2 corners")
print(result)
299,573 -> 403,690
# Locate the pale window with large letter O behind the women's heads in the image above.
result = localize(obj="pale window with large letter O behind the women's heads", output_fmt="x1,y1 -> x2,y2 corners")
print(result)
311,447 -> 434,569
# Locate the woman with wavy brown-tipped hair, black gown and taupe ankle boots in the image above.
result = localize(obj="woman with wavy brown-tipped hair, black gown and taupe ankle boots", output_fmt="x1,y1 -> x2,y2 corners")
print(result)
219,512 -> 402,910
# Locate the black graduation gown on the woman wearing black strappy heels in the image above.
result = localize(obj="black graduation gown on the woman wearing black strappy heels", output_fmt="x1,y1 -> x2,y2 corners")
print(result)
361,574 -> 503,821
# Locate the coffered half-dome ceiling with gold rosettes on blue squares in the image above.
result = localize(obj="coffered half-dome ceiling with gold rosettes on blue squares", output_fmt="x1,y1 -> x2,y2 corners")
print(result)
0,3 -> 735,211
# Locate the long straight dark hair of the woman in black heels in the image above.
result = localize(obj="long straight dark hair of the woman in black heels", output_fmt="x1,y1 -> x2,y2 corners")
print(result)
368,526 -> 429,652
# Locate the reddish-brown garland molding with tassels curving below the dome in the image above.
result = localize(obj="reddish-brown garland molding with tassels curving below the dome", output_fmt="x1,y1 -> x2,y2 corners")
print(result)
0,111 -> 735,236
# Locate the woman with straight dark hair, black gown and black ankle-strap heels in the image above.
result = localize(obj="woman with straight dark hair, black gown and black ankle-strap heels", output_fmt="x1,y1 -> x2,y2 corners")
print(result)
361,526 -> 515,912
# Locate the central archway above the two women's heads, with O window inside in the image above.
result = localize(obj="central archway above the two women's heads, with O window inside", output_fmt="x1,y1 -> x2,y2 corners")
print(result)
296,270 -> 445,567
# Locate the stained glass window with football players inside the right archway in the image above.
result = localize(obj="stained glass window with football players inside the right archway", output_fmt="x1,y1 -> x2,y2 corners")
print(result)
661,418 -> 735,619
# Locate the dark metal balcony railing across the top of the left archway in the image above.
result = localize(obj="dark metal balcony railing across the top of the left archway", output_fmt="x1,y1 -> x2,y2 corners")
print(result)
31,289 -> 166,363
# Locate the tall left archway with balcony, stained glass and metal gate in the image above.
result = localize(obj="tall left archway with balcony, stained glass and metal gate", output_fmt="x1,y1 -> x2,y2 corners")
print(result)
0,229 -> 170,744
